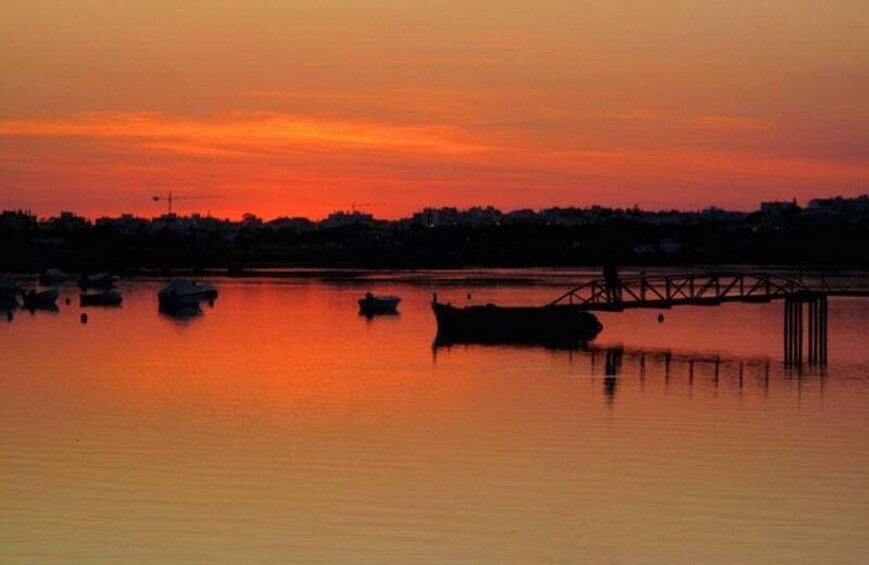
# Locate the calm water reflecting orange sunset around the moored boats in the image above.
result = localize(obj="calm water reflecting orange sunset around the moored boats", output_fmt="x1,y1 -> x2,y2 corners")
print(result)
0,273 -> 869,563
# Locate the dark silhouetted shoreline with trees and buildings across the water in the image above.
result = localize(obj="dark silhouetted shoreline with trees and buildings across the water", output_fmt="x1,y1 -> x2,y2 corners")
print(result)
0,195 -> 869,269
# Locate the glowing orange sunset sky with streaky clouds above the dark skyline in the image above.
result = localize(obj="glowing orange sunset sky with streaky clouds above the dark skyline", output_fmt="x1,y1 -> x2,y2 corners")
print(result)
0,0 -> 869,218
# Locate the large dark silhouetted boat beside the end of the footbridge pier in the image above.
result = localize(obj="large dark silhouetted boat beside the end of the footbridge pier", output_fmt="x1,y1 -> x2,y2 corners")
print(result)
432,295 -> 603,346
